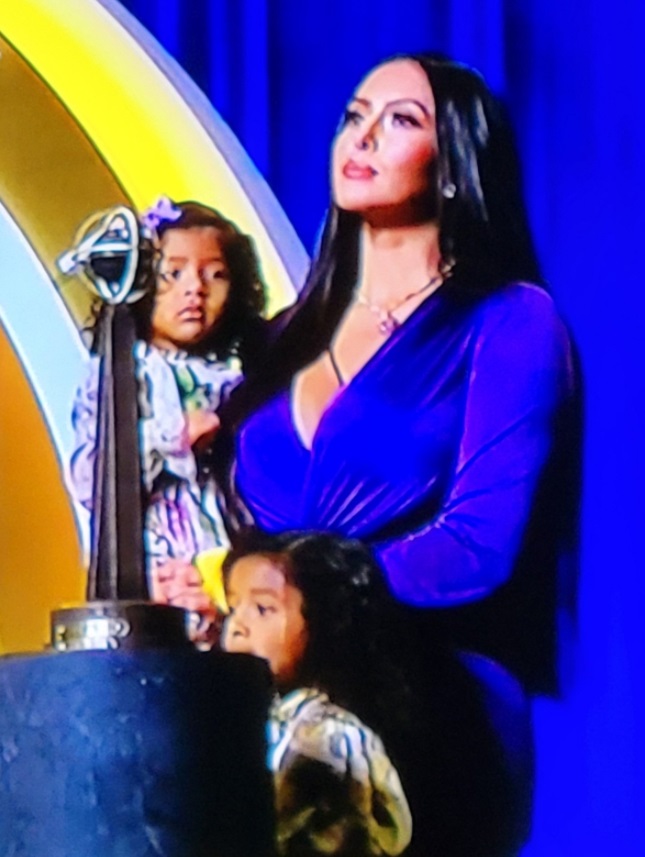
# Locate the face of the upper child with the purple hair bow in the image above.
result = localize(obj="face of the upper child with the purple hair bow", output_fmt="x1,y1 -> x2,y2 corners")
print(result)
151,226 -> 231,349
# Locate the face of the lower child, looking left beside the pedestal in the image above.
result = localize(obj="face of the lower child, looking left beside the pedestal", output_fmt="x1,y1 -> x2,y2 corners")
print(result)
222,556 -> 307,685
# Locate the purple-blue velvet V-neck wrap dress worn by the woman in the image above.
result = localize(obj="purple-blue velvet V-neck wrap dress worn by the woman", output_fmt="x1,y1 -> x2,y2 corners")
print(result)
237,283 -> 579,689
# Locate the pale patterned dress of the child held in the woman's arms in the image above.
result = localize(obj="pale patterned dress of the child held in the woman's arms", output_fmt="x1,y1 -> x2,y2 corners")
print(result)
70,342 -> 242,568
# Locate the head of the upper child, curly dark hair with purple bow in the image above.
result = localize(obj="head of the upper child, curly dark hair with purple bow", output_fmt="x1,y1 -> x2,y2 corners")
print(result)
133,201 -> 264,357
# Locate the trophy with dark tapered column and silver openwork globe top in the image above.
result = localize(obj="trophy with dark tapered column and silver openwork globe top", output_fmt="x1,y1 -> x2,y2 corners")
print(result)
51,206 -> 190,651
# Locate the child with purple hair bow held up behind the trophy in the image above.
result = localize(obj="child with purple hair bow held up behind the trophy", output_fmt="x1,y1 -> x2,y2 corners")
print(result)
71,197 -> 265,611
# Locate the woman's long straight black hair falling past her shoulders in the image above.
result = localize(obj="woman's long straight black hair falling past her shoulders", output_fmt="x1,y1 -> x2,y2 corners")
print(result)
224,53 -> 542,424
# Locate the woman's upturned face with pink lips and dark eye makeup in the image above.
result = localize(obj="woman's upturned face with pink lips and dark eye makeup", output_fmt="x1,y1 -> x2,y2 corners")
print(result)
332,60 -> 437,223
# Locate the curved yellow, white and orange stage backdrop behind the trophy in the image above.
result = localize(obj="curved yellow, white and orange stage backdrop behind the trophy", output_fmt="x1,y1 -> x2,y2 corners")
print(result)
0,0 -> 307,651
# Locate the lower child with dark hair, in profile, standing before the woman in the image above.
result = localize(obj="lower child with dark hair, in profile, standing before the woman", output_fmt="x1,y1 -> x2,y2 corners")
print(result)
223,533 -> 412,857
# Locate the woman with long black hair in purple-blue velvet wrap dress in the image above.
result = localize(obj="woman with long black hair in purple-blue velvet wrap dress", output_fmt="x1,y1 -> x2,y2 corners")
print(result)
219,55 -> 579,690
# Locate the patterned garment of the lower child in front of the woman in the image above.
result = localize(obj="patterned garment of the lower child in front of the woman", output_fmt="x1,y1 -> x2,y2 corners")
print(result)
269,689 -> 412,857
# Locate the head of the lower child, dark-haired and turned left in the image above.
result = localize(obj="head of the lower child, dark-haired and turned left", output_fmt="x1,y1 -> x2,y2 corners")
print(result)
223,533 -> 391,692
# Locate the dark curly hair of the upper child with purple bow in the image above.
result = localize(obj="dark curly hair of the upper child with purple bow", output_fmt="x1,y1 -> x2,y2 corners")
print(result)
132,201 -> 266,363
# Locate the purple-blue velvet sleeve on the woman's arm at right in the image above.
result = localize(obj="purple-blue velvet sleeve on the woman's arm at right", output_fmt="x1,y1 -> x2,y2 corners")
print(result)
375,287 -> 572,606
